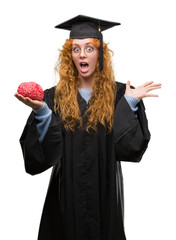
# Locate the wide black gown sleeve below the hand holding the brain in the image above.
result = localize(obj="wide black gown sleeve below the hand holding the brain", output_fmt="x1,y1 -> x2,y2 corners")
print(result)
20,87 -> 63,175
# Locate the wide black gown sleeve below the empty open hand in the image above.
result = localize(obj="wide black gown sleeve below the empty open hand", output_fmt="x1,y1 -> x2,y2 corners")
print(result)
113,96 -> 150,162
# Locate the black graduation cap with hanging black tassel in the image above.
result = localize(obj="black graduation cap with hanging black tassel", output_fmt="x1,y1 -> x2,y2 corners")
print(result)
55,15 -> 120,71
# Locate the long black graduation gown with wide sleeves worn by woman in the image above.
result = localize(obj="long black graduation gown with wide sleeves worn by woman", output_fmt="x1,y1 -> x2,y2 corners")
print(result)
20,82 -> 150,240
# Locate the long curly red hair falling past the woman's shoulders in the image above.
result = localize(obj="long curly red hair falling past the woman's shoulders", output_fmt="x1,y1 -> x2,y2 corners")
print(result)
54,38 -> 116,132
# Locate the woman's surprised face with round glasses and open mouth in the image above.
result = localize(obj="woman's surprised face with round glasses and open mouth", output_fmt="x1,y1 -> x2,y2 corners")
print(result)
72,38 -> 99,78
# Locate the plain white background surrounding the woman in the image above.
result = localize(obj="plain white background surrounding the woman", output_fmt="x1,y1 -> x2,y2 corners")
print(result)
0,0 -> 176,240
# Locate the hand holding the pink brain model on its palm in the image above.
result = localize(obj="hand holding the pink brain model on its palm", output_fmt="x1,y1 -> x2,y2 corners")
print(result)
14,93 -> 44,110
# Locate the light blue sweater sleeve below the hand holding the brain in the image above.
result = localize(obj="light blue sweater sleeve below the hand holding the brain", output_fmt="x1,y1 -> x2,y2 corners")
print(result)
33,102 -> 52,143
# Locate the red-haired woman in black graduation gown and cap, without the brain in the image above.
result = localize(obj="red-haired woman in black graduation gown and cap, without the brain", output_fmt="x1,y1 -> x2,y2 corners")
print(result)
15,16 -> 161,240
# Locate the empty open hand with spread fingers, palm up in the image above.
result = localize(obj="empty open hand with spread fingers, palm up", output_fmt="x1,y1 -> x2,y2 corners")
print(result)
125,81 -> 161,100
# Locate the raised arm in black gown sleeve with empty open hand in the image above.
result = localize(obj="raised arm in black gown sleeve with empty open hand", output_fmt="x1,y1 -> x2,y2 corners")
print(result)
113,81 -> 161,162
